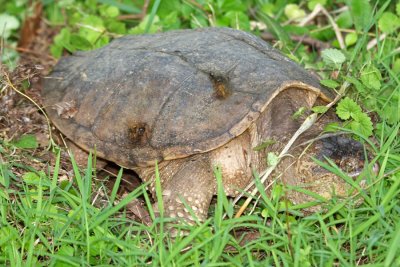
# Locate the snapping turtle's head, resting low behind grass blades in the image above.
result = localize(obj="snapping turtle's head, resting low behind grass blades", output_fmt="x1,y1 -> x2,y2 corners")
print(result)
283,135 -> 378,212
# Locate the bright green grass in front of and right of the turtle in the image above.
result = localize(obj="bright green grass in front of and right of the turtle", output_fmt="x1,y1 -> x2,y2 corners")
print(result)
0,1 -> 400,266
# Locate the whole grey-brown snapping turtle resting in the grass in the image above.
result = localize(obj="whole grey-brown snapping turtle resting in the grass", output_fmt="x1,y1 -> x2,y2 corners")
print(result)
42,28 -> 368,223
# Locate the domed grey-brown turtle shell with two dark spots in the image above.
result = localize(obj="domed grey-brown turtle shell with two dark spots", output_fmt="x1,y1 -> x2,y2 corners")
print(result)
42,28 -> 329,168
